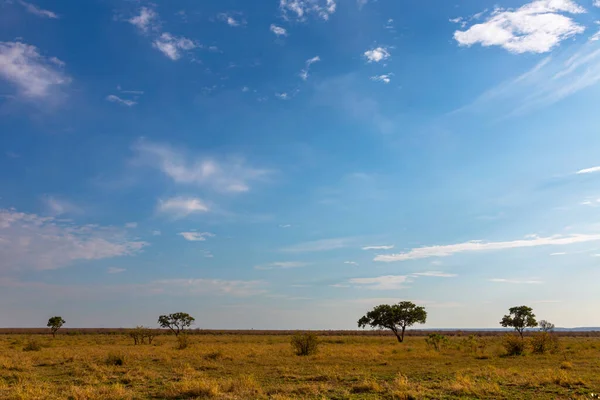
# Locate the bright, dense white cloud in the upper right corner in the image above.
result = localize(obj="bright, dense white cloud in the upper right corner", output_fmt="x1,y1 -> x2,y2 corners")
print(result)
454,0 -> 585,53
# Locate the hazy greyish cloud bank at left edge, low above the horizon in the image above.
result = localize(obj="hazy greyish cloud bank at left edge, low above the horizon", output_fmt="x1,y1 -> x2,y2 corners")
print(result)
0,209 -> 147,270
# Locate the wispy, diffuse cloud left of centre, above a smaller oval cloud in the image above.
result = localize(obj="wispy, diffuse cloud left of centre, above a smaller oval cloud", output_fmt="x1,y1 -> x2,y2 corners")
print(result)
133,141 -> 271,193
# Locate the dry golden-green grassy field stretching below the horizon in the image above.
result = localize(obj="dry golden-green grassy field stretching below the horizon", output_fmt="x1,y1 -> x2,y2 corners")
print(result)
0,334 -> 600,400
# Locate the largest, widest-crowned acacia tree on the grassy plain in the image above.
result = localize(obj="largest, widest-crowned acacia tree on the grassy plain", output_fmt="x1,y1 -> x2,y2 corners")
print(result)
358,301 -> 427,343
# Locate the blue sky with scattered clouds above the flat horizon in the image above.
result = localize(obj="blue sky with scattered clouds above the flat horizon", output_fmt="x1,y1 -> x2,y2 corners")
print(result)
0,0 -> 600,329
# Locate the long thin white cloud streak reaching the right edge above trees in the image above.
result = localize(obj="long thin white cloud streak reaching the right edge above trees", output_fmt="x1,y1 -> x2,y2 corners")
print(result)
374,234 -> 600,262
